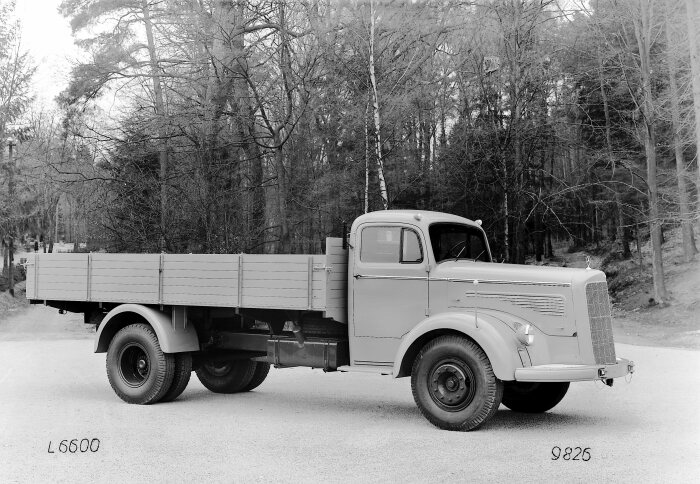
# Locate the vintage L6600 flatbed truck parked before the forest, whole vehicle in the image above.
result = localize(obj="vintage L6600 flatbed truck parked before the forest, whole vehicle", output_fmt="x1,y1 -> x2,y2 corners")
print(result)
27,210 -> 634,430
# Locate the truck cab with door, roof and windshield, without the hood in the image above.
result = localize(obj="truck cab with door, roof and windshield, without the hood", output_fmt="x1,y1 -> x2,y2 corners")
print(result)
348,210 -> 491,367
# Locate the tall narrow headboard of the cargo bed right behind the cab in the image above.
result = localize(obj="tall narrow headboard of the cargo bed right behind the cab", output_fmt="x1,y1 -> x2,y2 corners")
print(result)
326,237 -> 348,324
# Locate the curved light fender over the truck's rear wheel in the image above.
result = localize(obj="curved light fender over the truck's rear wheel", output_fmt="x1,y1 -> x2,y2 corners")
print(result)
95,304 -> 199,353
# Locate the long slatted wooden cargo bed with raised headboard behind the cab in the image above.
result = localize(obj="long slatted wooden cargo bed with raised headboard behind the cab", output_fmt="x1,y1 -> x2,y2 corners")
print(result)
27,238 -> 348,323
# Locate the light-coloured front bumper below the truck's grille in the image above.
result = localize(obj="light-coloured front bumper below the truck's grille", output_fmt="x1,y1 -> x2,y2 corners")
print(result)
515,358 -> 634,382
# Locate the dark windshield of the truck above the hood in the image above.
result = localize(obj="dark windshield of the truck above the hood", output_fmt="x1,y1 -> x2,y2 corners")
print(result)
429,223 -> 491,263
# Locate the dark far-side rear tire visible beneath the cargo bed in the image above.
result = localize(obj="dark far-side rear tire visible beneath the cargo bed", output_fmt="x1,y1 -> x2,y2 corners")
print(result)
195,356 -> 262,393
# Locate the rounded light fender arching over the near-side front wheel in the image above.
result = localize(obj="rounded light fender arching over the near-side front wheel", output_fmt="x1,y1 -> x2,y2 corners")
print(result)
393,313 -> 522,380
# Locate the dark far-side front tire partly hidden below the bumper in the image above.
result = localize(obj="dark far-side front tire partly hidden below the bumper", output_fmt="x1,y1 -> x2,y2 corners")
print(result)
502,382 -> 569,413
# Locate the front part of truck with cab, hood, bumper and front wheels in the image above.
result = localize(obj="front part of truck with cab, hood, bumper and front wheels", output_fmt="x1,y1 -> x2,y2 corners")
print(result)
348,210 -> 634,428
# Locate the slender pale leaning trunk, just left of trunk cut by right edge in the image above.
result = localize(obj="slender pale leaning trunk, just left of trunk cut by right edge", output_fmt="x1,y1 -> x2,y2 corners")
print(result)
664,0 -> 697,262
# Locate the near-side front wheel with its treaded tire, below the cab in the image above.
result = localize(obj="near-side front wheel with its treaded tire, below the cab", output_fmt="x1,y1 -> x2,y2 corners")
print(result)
411,335 -> 503,431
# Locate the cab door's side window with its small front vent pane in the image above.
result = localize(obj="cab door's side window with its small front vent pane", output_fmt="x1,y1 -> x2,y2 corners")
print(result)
360,227 -> 423,264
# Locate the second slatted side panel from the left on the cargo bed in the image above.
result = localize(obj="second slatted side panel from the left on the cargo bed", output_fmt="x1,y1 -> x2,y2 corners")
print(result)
89,253 -> 161,304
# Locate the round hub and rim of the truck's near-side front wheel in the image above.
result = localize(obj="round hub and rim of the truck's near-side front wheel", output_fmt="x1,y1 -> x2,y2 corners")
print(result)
428,359 -> 476,412
